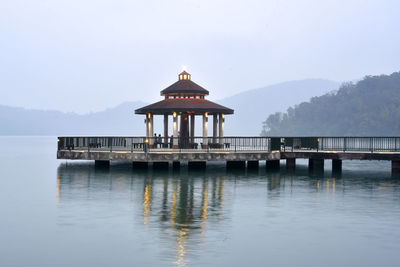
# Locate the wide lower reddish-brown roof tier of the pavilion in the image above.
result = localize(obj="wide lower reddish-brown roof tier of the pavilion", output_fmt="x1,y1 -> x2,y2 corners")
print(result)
135,98 -> 233,115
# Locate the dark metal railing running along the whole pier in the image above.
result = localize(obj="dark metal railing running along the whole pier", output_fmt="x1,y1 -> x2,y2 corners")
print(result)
58,136 -> 400,152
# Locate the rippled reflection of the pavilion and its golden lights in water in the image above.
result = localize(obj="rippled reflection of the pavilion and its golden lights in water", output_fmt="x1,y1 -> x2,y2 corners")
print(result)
143,177 -> 224,266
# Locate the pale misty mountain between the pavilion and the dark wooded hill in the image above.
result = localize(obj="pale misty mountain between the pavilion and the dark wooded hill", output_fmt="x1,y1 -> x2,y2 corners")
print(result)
217,79 -> 340,136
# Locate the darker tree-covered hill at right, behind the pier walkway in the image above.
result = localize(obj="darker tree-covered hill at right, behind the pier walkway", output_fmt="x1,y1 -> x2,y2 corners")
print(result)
262,72 -> 400,136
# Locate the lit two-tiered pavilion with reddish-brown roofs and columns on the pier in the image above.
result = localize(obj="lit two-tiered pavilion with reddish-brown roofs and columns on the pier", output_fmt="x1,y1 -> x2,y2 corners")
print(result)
135,71 -> 233,148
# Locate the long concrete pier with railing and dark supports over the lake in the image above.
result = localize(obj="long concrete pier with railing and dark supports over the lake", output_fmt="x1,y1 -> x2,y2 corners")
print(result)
57,137 -> 400,173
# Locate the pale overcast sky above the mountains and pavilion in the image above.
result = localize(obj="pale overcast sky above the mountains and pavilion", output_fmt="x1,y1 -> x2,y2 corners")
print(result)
0,0 -> 400,113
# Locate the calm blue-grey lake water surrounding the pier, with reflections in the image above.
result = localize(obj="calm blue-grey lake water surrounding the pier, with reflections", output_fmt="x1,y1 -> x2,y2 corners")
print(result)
0,137 -> 400,267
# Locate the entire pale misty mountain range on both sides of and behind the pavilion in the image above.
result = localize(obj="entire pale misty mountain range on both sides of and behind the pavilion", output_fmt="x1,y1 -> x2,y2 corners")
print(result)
0,79 -> 339,136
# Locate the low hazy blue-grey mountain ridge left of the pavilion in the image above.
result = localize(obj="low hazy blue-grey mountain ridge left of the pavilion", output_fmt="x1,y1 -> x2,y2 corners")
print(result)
0,102 -> 146,135
